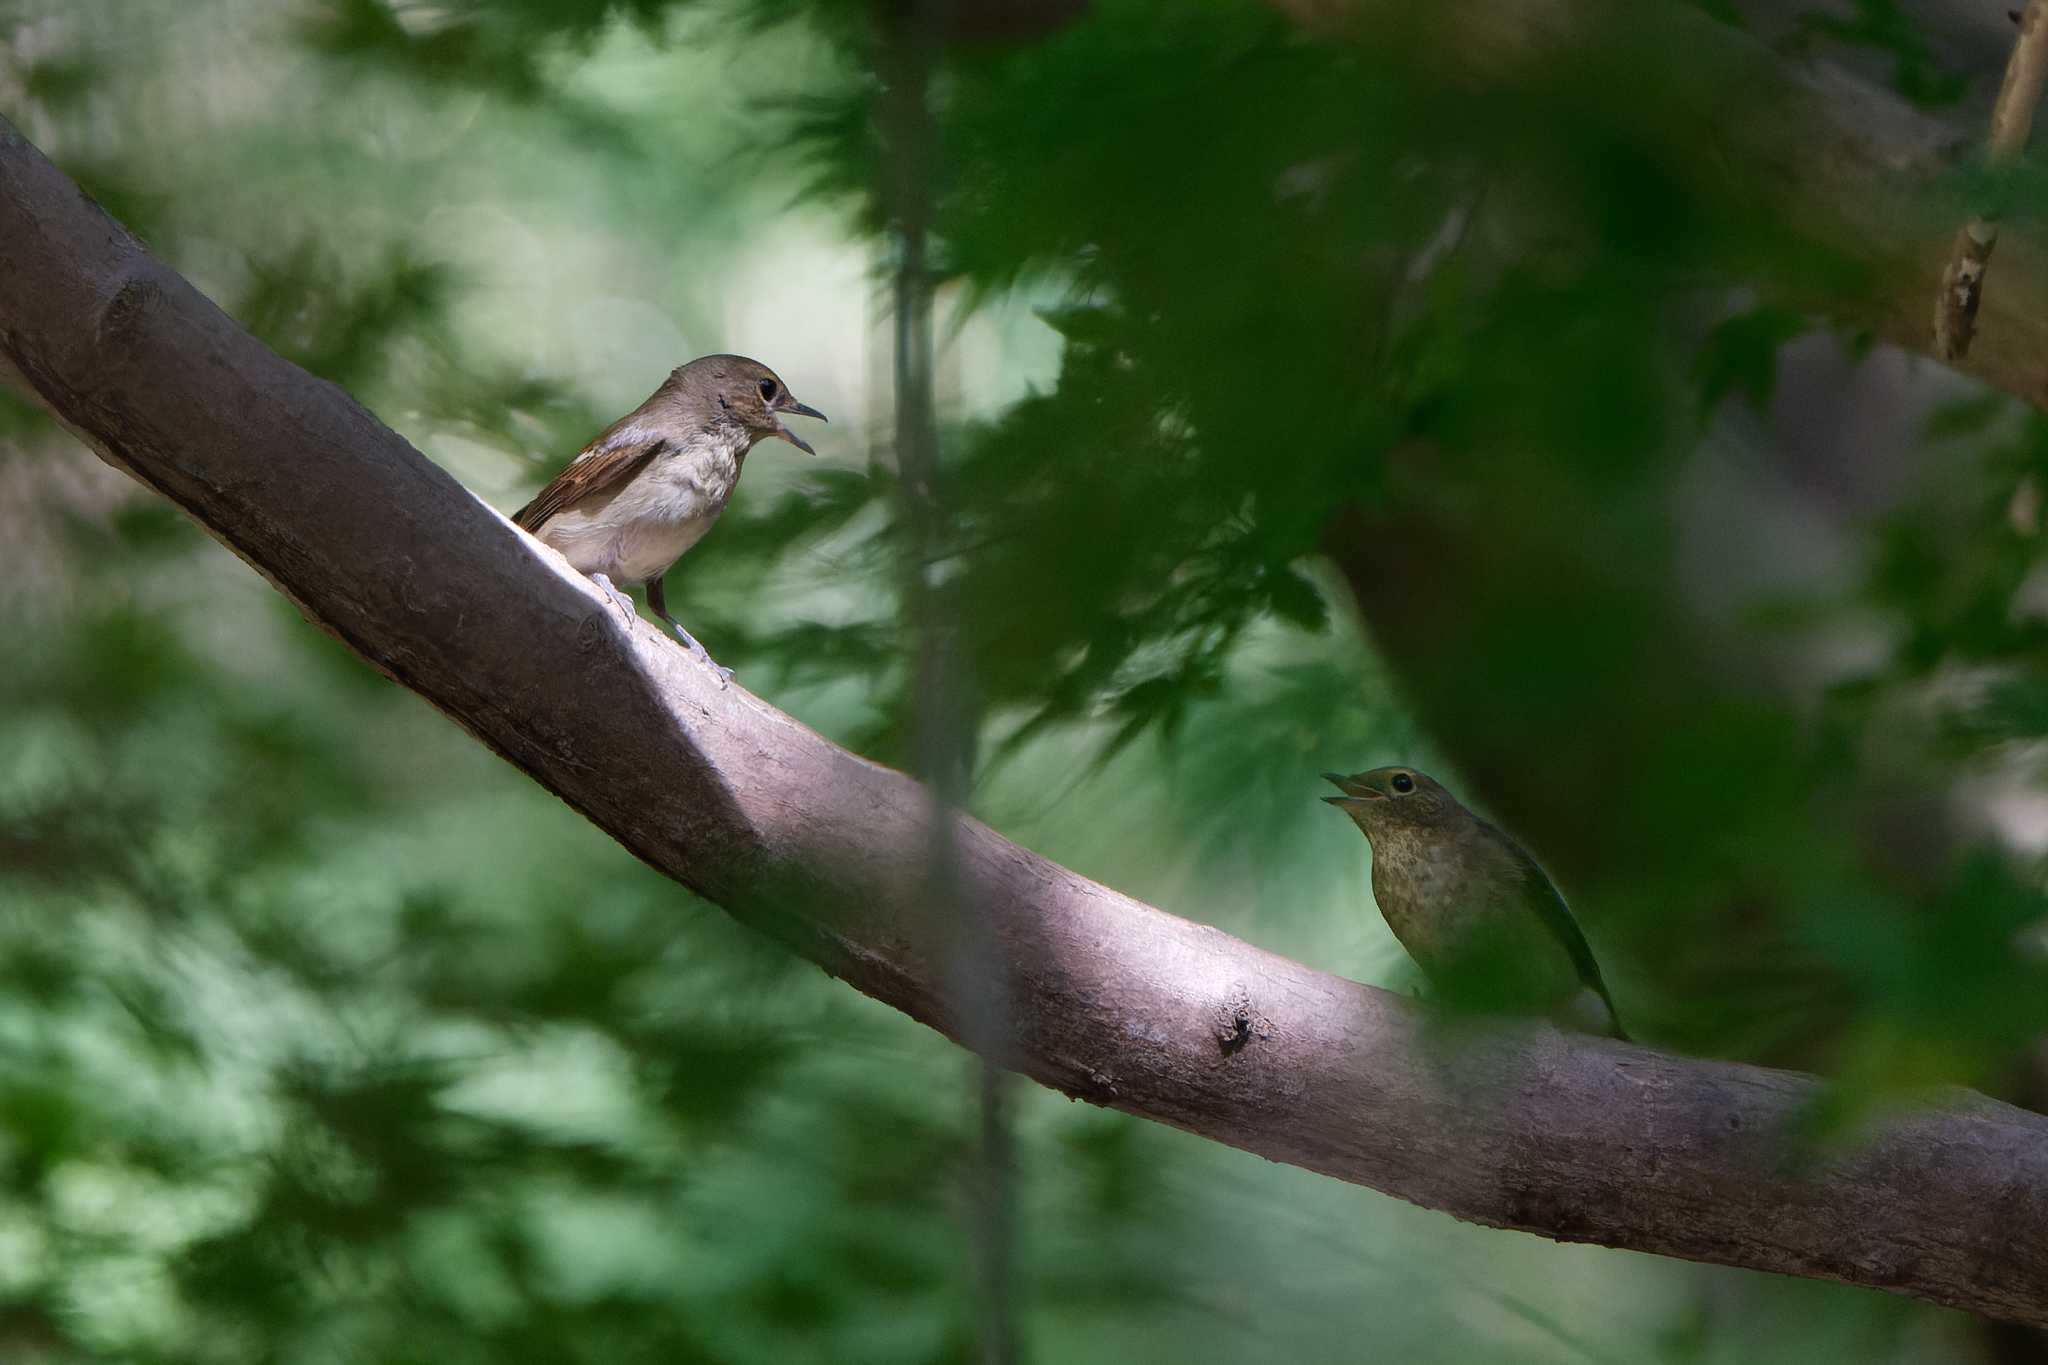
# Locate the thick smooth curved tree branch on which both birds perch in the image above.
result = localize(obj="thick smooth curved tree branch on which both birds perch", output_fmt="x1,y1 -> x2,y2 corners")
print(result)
0,123 -> 2048,1326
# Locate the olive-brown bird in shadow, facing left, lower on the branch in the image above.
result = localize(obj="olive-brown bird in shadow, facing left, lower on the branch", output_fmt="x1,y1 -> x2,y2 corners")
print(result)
1323,767 -> 1628,1038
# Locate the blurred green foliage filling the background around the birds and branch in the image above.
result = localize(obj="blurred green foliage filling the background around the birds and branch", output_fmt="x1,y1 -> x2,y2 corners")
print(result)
0,0 -> 2048,1363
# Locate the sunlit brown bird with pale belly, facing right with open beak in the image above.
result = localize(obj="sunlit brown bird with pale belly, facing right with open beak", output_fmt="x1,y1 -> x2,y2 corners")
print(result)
512,356 -> 825,681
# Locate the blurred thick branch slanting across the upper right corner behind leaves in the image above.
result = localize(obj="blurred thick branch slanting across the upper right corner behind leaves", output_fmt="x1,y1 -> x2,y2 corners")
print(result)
1272,0 -> 2048,407
